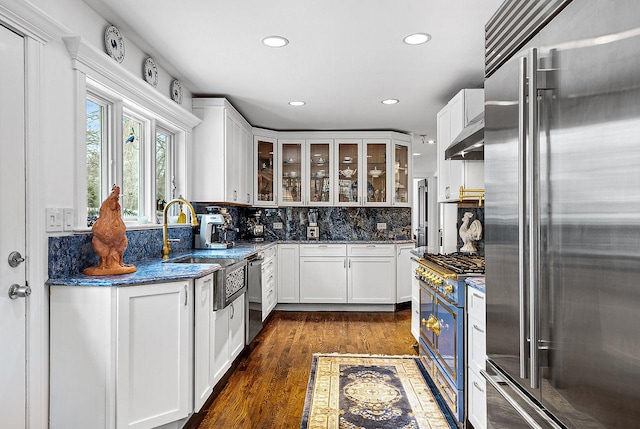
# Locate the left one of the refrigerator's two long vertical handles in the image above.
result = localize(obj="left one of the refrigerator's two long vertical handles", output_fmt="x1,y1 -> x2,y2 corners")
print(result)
518,52 -> 529,379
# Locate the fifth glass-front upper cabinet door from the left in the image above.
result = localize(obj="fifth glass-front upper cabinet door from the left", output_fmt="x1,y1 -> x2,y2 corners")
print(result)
364,139 -> 389,205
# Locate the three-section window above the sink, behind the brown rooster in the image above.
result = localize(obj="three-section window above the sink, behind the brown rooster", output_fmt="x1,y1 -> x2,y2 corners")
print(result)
85,93 -> 176,227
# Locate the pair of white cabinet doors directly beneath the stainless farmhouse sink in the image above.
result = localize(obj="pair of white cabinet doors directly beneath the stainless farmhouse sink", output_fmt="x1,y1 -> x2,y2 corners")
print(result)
211,294 -> 246,386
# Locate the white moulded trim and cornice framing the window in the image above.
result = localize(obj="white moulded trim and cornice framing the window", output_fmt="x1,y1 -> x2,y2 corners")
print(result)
62,36 -> 201,230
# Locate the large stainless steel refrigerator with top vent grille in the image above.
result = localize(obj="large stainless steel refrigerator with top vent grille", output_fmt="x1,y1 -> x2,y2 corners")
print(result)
483,0 -> 640,429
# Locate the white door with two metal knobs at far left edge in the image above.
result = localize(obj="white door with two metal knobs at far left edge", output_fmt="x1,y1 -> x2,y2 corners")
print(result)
0,25 -> 26,428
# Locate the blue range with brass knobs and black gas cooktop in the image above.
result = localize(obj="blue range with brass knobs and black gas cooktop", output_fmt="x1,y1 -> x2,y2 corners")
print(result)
415,253 -> 484,425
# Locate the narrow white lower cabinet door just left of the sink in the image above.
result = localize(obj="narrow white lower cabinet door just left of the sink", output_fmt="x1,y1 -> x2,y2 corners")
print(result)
193,274 -> 214,413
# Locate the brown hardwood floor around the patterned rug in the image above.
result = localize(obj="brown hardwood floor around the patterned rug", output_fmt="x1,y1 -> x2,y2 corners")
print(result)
198,310 -> 416,429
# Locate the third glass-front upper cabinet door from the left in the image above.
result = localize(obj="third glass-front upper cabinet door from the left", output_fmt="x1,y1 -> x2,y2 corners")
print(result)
307,140 -> 333,206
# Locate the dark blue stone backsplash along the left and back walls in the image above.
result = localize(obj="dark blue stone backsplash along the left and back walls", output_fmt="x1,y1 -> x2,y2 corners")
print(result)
49,203 -> 412,278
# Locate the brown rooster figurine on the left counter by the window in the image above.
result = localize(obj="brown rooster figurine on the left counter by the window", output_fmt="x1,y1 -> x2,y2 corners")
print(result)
82,185 -> 136,276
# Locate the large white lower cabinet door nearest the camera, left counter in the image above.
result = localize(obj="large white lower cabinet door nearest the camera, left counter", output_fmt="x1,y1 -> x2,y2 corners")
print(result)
116,281 -> 193,429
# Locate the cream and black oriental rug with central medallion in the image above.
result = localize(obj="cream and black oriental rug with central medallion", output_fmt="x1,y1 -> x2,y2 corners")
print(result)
300,354 -> 456,429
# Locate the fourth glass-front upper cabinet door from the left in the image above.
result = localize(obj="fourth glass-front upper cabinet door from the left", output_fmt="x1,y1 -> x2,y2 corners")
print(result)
335,139 -> 362,206
